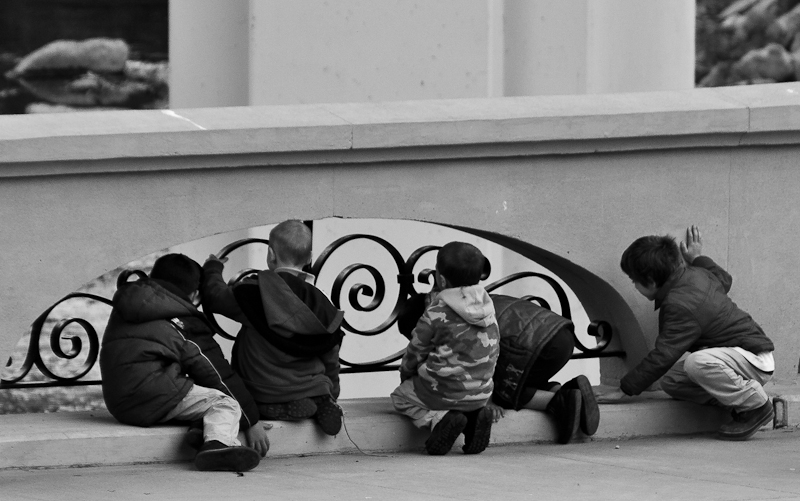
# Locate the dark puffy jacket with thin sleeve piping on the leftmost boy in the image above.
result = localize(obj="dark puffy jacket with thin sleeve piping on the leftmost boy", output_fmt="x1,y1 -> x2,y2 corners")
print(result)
100,279 -> 258,431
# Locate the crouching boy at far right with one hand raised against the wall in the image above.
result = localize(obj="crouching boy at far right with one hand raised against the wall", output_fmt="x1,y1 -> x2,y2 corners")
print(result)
604,226 -> 775,440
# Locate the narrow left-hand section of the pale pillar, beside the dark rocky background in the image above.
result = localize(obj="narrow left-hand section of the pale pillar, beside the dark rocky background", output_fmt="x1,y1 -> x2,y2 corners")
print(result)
169,0 -> 250,109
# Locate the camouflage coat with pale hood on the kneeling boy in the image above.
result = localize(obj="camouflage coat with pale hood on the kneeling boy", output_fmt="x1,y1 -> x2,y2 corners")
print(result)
400,285 -> 500,411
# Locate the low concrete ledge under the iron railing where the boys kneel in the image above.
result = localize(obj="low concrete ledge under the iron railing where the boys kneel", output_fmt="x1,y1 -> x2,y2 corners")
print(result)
0,394 -> 736,469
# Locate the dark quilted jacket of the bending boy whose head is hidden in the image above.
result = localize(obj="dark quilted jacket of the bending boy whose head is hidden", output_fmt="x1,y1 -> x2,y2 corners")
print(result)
492,294 -> 574,410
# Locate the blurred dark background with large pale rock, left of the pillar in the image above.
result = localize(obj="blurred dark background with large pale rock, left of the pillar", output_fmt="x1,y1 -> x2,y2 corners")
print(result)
0,0 -> 169,114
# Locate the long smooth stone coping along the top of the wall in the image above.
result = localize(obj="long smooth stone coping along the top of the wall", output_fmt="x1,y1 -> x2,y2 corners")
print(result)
0,82 -> 800,168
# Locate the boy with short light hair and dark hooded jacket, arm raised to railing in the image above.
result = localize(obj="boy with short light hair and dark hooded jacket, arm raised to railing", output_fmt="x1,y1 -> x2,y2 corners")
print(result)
202,220 -> 344,435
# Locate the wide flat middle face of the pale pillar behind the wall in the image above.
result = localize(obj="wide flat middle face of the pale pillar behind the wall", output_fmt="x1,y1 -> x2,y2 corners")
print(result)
249,0 -> 488,105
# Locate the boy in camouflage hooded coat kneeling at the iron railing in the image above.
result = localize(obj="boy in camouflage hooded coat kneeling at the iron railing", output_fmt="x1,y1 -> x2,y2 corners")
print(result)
391,242 -> 500,455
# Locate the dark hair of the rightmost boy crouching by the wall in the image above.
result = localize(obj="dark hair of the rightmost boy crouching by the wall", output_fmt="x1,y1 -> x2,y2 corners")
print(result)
619,235 -> 682,287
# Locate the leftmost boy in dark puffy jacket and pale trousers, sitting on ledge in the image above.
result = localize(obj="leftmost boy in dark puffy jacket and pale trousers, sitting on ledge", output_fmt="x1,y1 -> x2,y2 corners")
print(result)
100,254 -> 269,471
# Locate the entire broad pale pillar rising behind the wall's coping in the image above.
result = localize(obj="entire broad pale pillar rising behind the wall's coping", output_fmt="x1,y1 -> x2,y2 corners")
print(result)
170,0 -> 695,104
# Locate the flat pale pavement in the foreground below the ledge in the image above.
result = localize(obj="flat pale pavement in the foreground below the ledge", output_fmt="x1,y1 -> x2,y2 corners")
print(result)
0,427 -> 800,501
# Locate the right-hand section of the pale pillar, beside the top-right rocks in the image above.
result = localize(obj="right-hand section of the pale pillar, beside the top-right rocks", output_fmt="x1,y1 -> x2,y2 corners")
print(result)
504,0 -> 695,96
